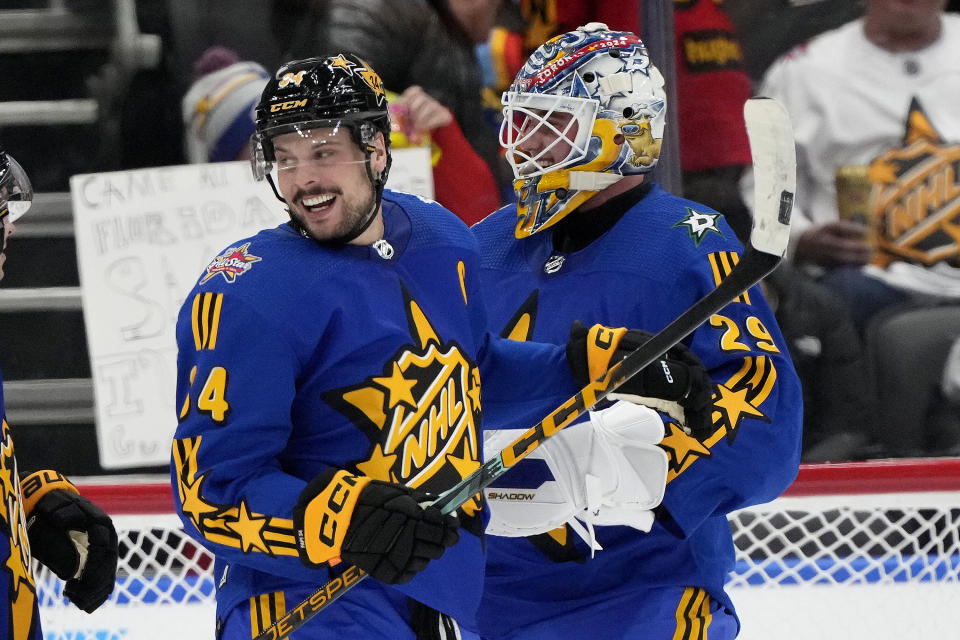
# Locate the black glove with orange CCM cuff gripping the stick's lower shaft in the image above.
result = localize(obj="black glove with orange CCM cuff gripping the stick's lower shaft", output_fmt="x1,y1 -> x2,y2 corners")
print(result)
293,469 -> 460,584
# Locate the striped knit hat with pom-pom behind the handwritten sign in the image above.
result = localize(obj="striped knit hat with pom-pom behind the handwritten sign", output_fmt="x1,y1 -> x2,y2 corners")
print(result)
182,51 -> 270,163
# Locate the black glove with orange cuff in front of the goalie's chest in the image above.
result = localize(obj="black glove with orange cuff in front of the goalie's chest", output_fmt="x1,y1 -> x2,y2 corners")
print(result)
567,320 -> 713,439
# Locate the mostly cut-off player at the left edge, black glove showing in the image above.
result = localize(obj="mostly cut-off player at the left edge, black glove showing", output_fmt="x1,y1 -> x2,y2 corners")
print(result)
0,147 -> 118,640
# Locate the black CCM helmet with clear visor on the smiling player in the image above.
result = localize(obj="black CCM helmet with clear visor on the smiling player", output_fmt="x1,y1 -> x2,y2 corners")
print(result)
250,53 -> 391,243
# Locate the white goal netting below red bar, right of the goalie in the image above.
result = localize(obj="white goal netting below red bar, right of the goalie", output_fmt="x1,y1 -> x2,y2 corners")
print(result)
729,459 -> 960,640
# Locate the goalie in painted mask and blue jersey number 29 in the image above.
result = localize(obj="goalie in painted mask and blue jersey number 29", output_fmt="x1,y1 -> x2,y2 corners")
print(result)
473,23 -> 801,640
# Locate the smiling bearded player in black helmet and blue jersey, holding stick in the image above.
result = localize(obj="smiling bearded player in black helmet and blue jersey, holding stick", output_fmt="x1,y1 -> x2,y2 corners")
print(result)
171,54 -> 632,640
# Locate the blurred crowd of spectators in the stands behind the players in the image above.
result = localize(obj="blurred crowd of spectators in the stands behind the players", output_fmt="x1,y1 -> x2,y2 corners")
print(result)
0,0 -> 960,470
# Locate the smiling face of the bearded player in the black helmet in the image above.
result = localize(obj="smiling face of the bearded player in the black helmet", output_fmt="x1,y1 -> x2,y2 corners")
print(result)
273,127 -> 386,241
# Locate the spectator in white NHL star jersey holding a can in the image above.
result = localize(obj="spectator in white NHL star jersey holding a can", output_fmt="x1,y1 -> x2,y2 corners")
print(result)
744,0 -> 960,455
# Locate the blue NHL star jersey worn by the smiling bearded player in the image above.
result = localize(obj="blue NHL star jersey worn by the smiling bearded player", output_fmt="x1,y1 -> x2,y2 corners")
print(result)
171,191 -> 576,639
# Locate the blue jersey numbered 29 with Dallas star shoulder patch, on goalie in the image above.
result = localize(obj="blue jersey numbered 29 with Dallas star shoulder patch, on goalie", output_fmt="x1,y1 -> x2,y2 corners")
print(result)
473,184 -> 802,640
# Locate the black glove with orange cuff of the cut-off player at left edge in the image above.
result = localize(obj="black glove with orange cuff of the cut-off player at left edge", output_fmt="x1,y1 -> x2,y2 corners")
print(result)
20,471 -> 118,613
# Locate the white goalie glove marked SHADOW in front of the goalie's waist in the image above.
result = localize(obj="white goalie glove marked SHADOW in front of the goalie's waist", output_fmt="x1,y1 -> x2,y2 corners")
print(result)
484,401 -> 668,551
